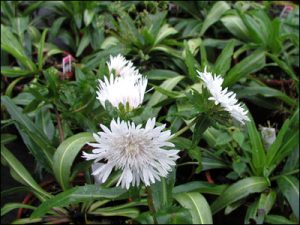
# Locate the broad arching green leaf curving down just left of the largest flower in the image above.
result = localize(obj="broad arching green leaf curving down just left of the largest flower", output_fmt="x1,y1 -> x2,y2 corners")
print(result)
53,132 -> 94,190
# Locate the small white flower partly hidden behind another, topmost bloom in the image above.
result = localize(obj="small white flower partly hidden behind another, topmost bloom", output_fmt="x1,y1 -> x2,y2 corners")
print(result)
107,54 -> 141,76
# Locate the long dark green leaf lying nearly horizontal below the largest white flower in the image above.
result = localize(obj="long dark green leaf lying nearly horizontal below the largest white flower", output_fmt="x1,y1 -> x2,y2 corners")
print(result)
31,185 -> 128,219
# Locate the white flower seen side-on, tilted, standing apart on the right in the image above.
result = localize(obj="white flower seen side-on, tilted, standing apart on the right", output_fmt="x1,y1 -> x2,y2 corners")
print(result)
197,68 -> 249,124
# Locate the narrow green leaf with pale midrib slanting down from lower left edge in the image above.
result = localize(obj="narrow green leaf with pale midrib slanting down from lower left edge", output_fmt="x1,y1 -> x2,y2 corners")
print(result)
1,145 -> 50,200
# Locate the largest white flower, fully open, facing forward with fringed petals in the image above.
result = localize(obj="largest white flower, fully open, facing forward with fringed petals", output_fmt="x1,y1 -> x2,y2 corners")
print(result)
83,118 -> 179,189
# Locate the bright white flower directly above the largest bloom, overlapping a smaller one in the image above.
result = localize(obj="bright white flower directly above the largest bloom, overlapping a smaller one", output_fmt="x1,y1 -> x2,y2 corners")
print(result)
97,74 -> 148,110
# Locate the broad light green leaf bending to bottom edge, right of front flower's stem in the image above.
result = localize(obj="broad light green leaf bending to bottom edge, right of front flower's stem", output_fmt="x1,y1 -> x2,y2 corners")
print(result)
174,192 -> 213,224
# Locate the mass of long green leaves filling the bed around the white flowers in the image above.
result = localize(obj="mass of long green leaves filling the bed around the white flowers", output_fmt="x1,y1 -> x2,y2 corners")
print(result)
1,1 -> 299,224
